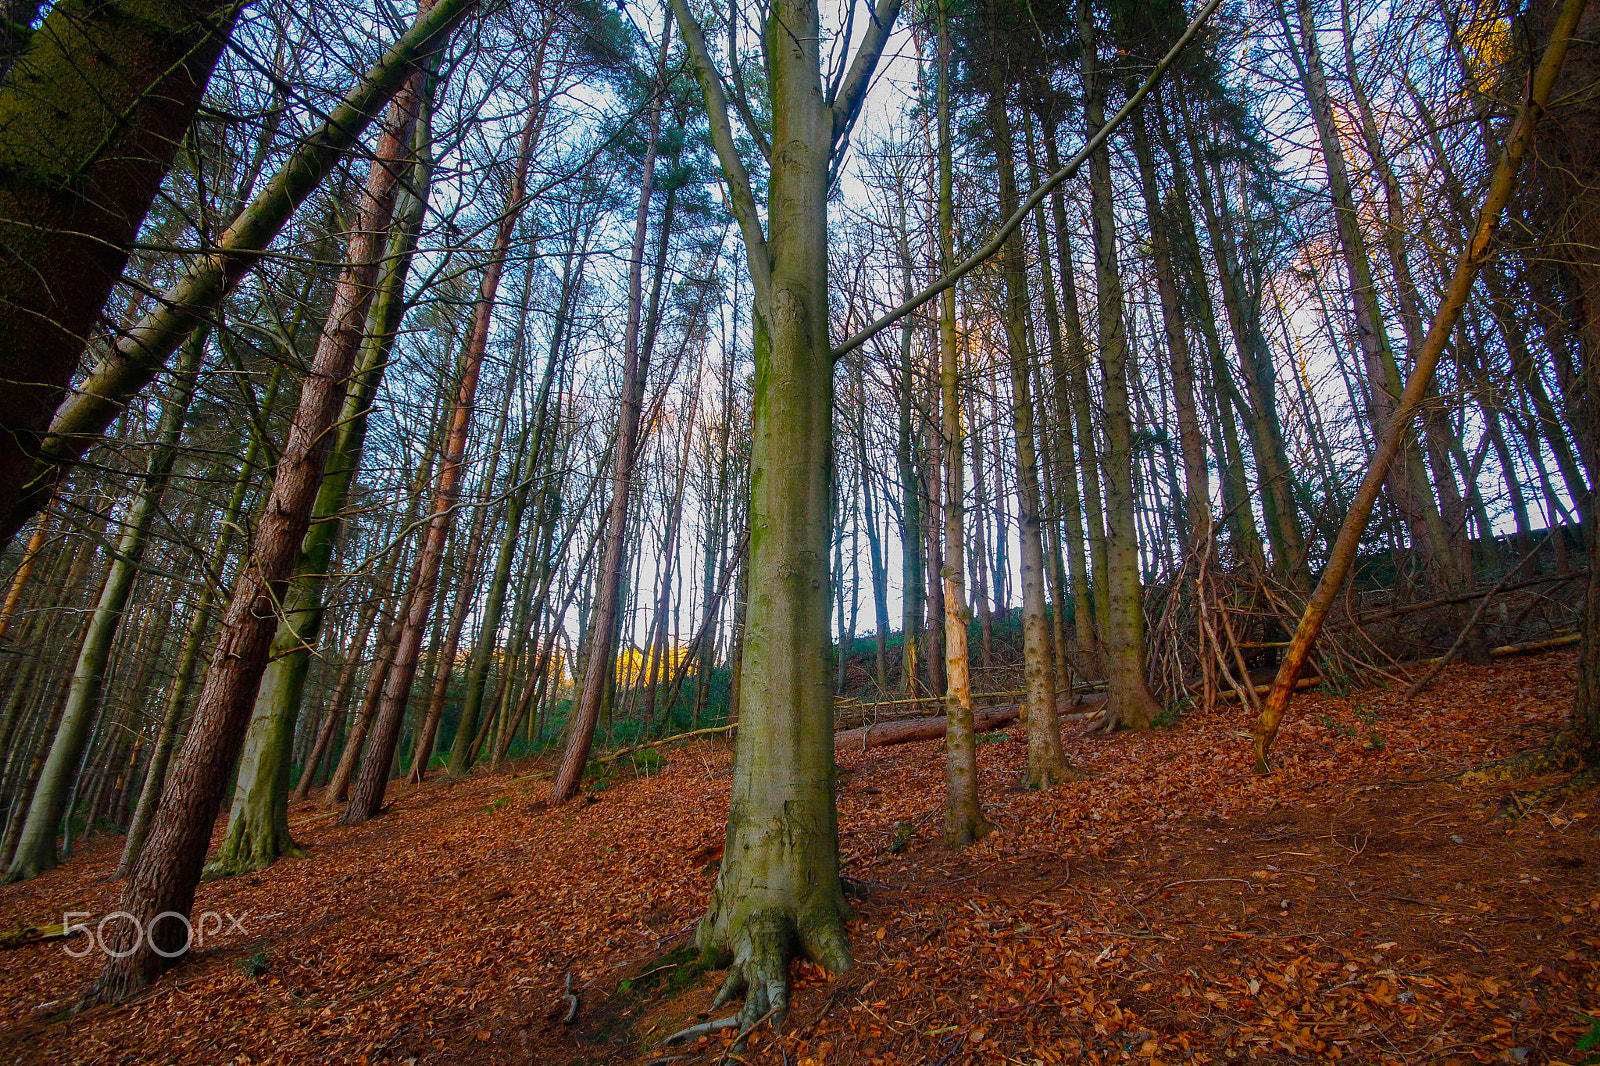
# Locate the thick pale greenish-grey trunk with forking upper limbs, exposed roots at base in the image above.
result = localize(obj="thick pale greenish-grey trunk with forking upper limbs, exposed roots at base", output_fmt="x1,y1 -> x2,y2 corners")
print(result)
672,0 -> 899,1029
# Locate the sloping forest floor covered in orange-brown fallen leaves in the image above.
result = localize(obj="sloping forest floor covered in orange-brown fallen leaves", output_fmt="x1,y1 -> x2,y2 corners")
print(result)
0,651 -> 1600,1066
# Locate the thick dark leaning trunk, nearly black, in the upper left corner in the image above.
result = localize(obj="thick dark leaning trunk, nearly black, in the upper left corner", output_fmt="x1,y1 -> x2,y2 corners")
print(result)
0,0 -> 238,531
